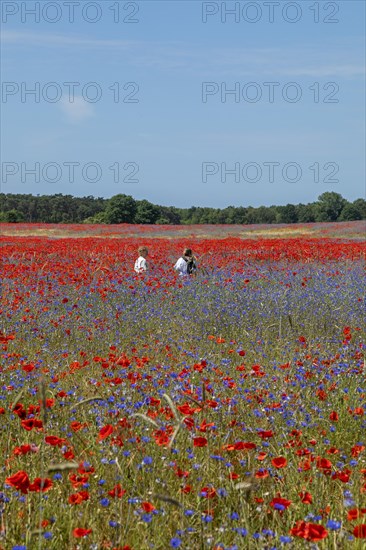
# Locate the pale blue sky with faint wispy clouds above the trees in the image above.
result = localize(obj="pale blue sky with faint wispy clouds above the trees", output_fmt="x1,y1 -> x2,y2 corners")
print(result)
1,0 -> 365,207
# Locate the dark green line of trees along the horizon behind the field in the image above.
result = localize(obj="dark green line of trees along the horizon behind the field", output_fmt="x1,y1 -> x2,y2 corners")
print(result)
0,191 -> 366,225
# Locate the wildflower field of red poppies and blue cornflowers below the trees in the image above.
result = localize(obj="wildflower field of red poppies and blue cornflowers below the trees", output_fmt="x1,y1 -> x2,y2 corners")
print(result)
0,222 -> 366,550
